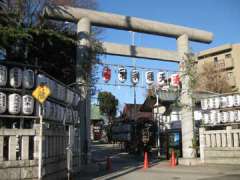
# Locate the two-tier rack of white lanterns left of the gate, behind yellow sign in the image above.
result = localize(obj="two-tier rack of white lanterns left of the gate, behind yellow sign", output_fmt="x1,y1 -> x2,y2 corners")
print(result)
0,64 -> 80,123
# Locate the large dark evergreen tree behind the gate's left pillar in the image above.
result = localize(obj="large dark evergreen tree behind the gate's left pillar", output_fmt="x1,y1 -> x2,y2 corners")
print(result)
0,0 -> 102,84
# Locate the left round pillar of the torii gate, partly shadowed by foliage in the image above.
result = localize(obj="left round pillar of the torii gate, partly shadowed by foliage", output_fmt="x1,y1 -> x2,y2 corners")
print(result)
76,17 -> 91,164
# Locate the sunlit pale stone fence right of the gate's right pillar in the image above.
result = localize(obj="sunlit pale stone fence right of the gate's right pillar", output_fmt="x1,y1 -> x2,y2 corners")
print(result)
199,126 -> 240,164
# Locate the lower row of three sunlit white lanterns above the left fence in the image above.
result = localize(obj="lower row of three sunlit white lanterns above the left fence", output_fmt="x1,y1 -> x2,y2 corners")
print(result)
0,92 -> 34,115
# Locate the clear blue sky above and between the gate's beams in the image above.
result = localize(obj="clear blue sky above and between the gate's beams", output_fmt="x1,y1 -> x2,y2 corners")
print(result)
92,0 -> 240,111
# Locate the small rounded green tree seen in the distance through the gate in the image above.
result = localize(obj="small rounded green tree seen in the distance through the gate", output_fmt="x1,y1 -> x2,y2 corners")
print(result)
98,91 -> 118,123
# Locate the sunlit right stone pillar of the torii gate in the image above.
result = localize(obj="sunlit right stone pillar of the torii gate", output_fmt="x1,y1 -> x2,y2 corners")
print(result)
177,34 -> 195,158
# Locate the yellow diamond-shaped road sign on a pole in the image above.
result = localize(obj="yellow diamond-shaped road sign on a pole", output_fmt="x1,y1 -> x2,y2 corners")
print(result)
32,85 -> 51,103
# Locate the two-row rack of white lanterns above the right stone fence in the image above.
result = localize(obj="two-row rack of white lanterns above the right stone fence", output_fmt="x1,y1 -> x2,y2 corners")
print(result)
201,94 -> 240,125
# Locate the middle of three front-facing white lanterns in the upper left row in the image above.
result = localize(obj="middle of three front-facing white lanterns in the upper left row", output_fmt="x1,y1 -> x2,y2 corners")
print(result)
9,67 -> 23,88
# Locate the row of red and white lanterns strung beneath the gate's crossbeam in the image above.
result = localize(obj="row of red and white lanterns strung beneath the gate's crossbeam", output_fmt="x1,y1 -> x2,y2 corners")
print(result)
102,66 -> 180,87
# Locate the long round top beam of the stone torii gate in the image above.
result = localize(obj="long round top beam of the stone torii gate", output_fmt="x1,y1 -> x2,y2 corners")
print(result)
43,6 -> 213,43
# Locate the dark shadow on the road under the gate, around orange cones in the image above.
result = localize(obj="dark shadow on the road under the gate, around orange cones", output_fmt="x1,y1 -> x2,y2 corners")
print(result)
74,143 -> 158,180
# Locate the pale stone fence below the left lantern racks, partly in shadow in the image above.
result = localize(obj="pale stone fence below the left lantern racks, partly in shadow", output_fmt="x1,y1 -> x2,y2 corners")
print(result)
0,127 -> 80,180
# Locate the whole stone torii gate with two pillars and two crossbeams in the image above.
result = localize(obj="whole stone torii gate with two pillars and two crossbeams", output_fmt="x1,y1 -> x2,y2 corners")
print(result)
44,6 -> 213,163
